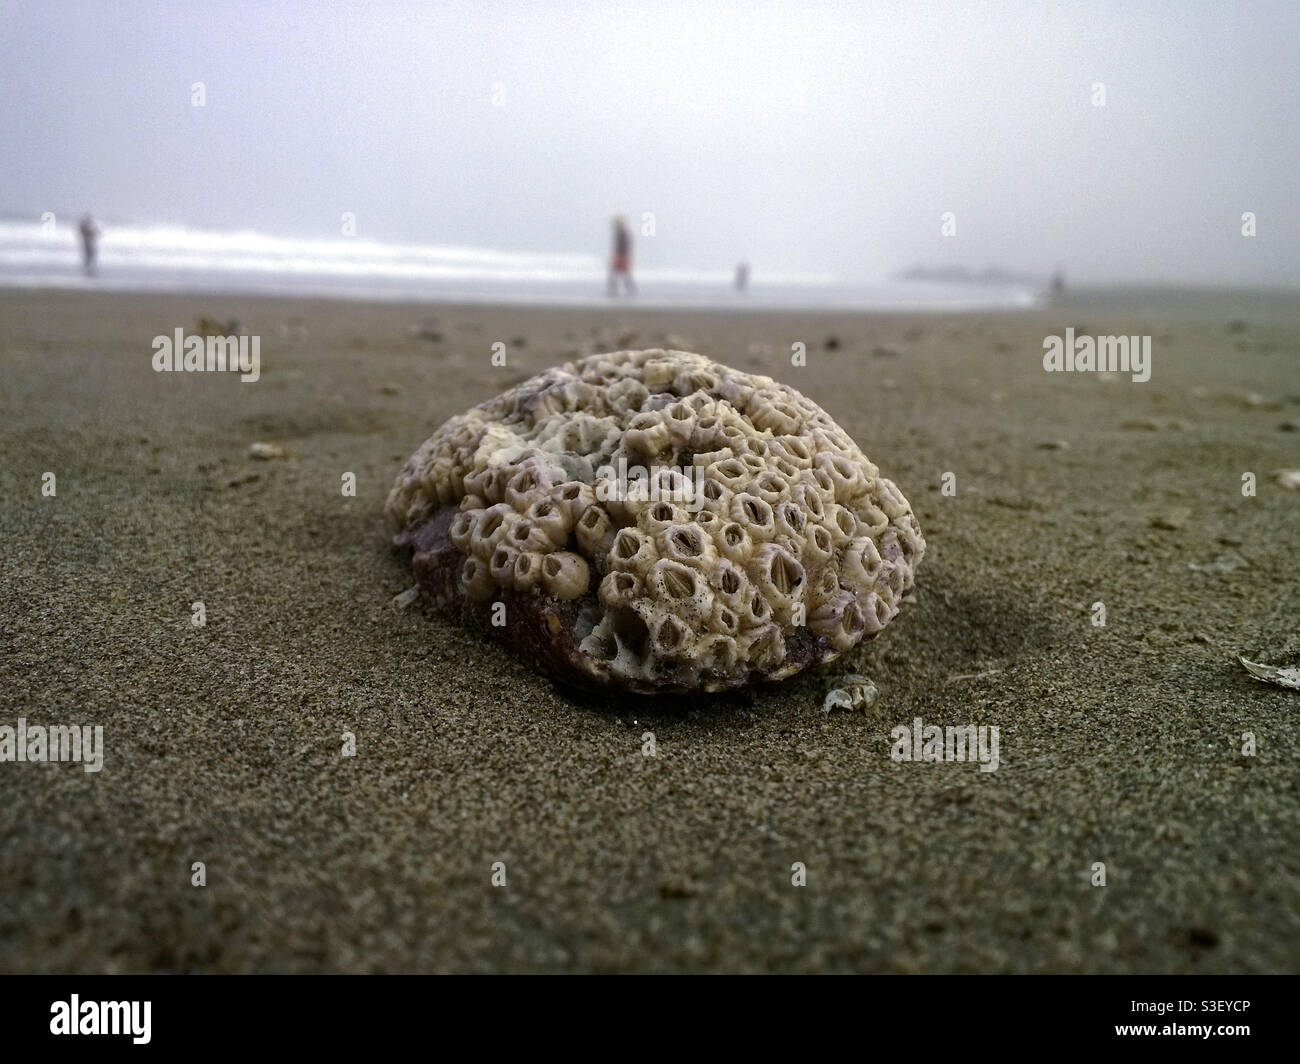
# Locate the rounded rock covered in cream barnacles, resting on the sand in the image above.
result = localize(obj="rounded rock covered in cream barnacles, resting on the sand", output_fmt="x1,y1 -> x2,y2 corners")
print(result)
387,350 -> 926,692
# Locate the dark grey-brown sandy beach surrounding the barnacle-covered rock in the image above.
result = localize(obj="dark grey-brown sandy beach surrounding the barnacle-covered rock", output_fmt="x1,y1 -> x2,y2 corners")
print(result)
0,290 -> 1300,973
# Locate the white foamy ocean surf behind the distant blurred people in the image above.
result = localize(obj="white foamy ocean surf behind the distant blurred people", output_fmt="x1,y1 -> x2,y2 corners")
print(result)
0,219 -> 1034,308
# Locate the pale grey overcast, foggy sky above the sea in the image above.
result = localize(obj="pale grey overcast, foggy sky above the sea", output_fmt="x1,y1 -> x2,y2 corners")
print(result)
0,0 -> 1300,285
